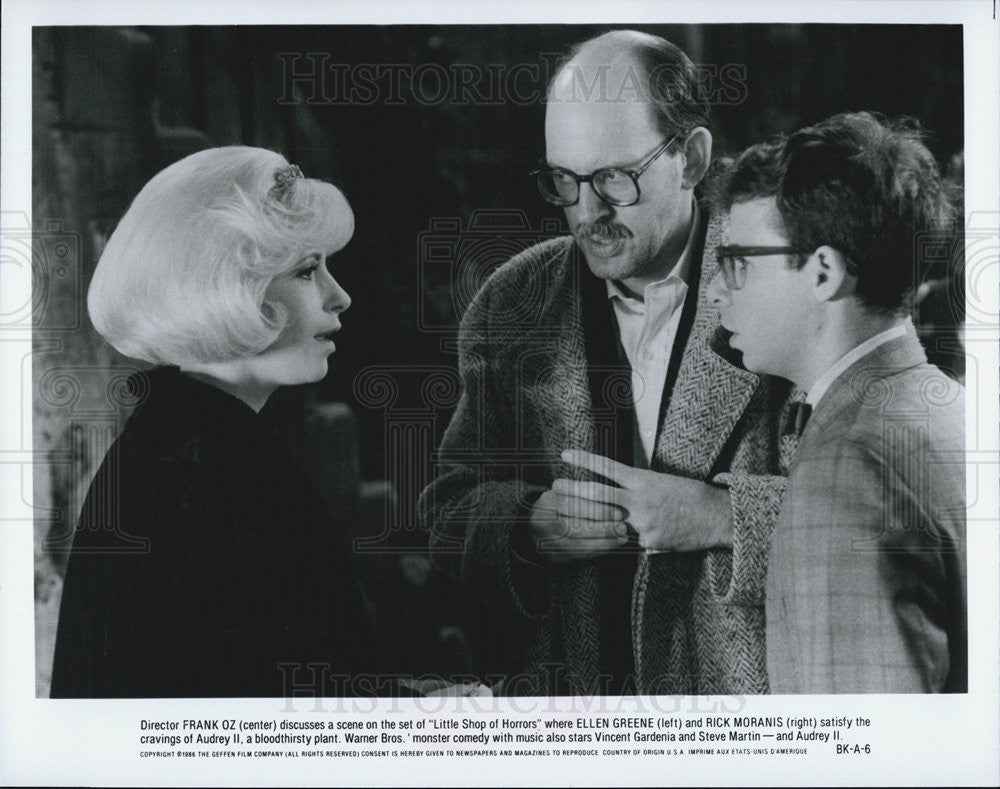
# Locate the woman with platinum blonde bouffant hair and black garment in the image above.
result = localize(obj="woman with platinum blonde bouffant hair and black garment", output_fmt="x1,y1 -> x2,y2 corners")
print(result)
51,147 -> 375,697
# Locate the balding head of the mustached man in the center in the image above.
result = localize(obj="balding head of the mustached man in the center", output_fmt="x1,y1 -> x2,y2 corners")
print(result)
542,30 -> 712,294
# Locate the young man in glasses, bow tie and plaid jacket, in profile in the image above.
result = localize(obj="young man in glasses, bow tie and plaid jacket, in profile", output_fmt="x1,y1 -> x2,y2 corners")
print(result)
710,113 -> 967,693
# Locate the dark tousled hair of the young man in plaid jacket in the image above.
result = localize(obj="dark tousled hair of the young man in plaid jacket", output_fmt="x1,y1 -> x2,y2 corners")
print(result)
710,112 -> 952,312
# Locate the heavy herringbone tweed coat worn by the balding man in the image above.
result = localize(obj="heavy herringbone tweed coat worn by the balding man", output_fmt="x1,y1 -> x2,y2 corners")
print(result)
420,211 -> 794,695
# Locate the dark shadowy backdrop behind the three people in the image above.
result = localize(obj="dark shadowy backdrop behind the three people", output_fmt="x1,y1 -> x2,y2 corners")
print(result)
33,24 -> 964,688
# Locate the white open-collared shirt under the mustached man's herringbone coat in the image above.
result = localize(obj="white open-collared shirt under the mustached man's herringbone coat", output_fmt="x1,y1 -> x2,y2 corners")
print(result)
607,203 -> 701,468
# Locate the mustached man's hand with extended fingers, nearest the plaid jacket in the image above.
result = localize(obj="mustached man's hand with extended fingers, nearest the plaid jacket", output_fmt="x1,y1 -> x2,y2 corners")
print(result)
556,449 -> 733,551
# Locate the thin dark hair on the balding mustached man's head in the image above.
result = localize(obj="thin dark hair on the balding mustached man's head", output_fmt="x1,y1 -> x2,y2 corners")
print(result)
549,30 -> 711,137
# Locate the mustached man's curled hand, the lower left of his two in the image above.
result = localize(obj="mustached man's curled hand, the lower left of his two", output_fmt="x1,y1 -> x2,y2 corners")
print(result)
531,480 -> 628,562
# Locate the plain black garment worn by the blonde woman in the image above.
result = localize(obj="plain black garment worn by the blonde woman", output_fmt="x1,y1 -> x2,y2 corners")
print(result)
51,369 -> 375,697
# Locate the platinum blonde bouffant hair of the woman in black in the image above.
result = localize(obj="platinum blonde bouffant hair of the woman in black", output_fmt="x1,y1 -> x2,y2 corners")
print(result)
87,146 -> 354,365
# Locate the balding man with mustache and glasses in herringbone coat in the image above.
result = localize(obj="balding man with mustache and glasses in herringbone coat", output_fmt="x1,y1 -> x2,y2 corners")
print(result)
421,31 -> 791,695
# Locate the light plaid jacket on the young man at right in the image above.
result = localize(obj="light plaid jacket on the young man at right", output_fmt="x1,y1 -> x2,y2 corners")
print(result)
766,329 -> 967,693
